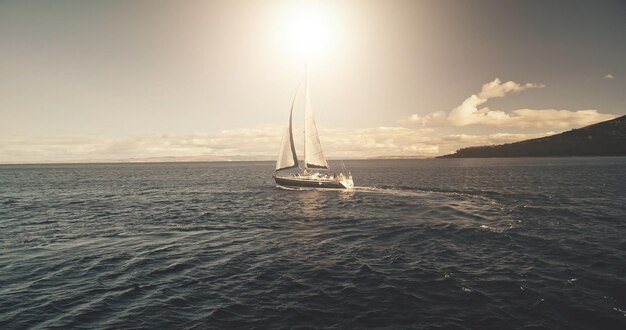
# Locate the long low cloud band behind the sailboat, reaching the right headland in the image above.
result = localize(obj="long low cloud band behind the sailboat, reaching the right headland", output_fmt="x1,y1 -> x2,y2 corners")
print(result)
0,126 -> 554,163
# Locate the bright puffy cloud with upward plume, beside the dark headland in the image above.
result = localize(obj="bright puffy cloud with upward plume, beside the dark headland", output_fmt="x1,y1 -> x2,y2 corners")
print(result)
401,78 -> 615,129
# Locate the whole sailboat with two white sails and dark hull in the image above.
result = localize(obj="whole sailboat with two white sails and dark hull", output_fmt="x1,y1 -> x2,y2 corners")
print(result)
273,70 -> 354,189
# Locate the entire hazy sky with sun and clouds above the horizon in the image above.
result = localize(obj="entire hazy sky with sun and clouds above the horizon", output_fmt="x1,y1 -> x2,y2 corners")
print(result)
0,0 -> 626,163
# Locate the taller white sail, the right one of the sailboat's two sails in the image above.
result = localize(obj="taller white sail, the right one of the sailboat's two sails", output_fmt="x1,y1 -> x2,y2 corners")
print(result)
304,74 -> 328,168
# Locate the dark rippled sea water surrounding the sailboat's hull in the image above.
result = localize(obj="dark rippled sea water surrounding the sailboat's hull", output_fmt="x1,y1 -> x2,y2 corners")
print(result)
0,158 -> 626,329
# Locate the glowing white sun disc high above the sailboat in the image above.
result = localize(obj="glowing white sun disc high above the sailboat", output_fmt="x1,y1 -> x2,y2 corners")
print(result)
282,3 -> 335,63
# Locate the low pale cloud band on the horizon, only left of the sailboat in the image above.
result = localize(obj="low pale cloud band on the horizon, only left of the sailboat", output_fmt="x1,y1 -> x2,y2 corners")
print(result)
0,126 -> 282,163
